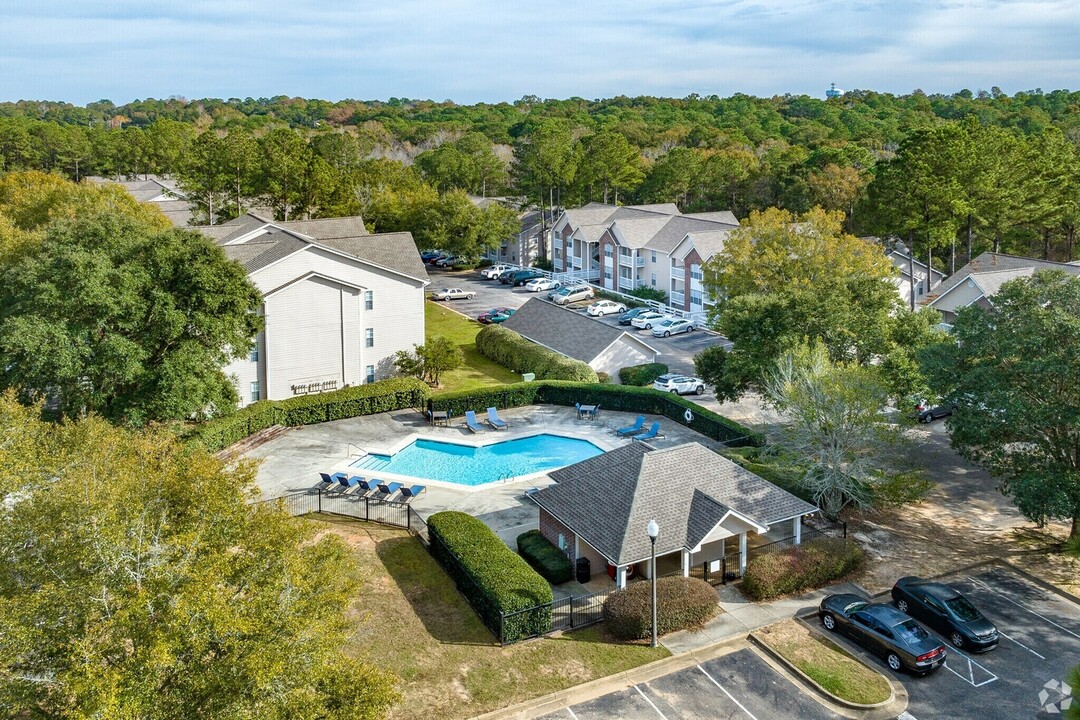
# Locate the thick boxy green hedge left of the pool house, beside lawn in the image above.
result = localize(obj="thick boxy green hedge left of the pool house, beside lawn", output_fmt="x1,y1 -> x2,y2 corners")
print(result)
428,511 -> 553,644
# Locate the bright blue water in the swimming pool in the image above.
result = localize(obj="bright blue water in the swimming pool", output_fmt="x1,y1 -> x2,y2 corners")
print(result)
352,435 -> 603,486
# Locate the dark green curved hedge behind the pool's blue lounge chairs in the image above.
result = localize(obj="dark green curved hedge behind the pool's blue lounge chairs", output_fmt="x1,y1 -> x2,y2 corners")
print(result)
428,380 -> 765,447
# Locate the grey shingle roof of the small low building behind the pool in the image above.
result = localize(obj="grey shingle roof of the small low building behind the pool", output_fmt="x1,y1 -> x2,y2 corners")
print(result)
502,298 -> 656,363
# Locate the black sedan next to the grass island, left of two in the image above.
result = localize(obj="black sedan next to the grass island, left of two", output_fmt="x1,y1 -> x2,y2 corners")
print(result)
818,593 -> 948,675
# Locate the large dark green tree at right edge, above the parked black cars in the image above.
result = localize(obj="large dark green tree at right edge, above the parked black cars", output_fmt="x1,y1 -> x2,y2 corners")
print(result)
929,271 -> 1080,539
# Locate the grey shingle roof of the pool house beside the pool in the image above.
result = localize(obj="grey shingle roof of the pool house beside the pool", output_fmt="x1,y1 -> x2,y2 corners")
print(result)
531,443 -> 818,565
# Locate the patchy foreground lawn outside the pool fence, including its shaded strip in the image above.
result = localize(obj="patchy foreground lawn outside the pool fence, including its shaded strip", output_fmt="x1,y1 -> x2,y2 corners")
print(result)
310,520 -> 669,720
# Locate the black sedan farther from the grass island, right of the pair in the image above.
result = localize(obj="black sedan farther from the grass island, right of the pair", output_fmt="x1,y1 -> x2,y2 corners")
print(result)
892,576 -> 998,650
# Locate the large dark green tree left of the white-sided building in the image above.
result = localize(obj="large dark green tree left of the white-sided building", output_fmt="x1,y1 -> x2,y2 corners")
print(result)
0,210 -> 261,424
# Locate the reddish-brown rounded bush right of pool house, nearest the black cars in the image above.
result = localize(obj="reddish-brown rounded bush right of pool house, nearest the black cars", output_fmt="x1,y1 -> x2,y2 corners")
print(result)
742,538 -> 866,600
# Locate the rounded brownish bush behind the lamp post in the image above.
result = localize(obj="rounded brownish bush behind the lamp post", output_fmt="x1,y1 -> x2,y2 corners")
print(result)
604,576 -> 719,640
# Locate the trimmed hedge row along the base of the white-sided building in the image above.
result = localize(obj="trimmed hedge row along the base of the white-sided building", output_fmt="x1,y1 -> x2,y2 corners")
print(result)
186,378 -> 429,452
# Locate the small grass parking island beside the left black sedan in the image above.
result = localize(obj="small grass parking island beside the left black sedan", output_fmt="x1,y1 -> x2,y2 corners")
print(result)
756,620 -> 890,705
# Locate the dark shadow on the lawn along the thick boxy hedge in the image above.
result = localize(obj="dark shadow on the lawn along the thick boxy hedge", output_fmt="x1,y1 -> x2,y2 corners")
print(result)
375,536 -> 498,646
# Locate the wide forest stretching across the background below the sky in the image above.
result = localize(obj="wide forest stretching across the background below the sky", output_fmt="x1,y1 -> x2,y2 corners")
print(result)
0,87 -> 1080,272
